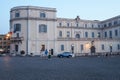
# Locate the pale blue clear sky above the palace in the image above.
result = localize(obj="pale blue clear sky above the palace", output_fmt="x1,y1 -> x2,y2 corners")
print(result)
0,0 -> 120,34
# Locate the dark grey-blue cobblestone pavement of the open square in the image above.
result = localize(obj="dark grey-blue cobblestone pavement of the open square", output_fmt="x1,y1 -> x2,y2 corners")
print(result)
0,56 -> 120,80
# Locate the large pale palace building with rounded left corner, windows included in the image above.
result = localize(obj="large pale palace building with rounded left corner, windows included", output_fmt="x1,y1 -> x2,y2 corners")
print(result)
10,6 -> 120,56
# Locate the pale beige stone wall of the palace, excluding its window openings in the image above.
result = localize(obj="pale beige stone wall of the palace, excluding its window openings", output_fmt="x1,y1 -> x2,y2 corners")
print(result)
10,6 -> 120,55
